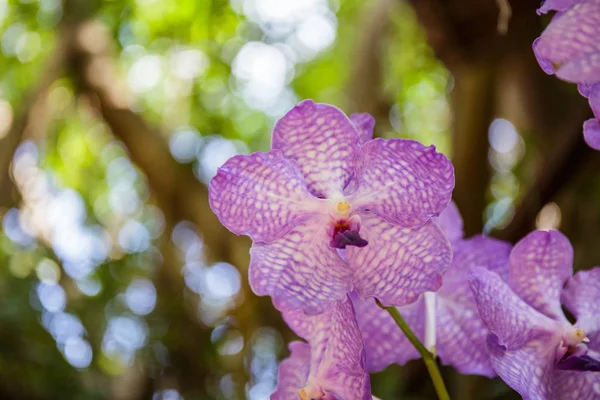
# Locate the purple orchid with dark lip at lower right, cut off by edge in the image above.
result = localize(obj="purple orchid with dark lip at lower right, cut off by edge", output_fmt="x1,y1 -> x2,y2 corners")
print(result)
470,231 -> 600,399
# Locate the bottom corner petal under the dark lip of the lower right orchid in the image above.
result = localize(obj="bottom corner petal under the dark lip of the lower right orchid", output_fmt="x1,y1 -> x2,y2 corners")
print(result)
552,371 -> 600,400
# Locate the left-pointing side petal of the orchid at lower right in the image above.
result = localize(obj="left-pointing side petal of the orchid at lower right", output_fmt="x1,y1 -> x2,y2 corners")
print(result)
469,267 -> 562,351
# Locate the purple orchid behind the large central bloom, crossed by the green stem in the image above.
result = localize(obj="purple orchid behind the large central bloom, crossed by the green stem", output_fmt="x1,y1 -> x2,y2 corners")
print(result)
353,203 -> 511,377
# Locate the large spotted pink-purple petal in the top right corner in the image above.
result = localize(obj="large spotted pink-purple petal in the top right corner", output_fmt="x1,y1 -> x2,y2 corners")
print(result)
535,0 -> 600,83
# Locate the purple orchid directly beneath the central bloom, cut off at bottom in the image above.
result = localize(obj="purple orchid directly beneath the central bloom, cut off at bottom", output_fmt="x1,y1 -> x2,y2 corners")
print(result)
271,298 -> 372,400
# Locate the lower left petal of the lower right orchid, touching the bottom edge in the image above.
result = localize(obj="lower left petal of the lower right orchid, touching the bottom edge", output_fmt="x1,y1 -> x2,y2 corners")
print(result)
487,332 -> 560,400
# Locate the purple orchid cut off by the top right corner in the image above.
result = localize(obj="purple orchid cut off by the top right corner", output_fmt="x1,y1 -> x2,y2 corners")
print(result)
533,0 -> 600,150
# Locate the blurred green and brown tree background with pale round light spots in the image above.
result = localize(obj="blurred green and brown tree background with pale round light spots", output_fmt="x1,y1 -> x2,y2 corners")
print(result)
0,0 -> 600,400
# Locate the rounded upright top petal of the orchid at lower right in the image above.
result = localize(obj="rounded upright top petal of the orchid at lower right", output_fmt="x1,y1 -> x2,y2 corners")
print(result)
508,230 -> 573,321
